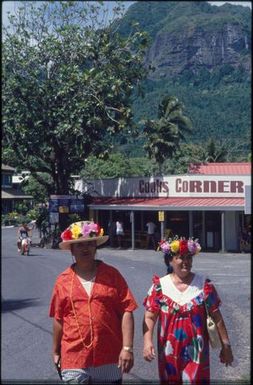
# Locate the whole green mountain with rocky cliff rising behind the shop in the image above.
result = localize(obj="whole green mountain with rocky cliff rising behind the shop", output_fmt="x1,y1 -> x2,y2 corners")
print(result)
116,1 -> 251,160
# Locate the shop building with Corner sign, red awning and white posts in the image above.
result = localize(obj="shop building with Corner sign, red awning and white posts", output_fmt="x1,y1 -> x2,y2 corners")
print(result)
76,163 -> 251,252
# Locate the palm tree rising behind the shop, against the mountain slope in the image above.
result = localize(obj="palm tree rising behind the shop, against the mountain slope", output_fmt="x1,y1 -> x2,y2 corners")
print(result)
143,96 -> 191,174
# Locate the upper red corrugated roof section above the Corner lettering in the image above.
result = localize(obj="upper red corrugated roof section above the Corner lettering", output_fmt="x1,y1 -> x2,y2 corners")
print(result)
188,162 -> 251,175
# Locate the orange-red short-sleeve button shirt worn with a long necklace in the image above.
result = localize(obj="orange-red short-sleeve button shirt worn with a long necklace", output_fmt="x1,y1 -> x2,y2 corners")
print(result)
49,261 -> 138,369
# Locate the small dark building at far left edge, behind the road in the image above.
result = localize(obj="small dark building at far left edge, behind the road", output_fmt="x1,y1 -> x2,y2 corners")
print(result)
1,164 -> 33,214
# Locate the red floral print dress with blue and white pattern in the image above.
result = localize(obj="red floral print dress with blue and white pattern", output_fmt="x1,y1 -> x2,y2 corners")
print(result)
144,274 -> 221,385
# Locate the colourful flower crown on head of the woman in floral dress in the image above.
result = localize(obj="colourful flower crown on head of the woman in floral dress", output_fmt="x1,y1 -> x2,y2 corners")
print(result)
158,236 -> 201,255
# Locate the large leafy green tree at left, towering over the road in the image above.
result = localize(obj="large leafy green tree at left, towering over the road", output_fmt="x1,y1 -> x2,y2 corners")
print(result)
2,1 -> 147,194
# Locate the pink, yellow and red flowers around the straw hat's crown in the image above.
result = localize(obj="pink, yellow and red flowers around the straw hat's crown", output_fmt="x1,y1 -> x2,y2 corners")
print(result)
61,221 -> 104,241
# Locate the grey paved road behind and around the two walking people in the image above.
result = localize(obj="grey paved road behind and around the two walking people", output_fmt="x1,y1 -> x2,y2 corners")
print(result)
1,228 -> 250,383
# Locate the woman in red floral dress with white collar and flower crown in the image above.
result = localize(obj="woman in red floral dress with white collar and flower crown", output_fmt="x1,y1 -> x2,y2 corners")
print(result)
143,239 -> 233,385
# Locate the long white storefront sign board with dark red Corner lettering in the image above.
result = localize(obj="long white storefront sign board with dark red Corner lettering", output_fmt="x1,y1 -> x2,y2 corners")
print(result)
80,175 -> 251,198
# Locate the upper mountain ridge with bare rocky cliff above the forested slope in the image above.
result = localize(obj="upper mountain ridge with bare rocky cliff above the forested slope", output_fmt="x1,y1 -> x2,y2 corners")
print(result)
120,1 -> 251,79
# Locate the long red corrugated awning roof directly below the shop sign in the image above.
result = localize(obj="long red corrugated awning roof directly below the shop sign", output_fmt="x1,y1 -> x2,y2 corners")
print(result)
90,197 -> 244,210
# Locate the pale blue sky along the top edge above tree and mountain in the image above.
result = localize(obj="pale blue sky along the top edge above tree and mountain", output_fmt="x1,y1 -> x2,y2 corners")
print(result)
2,1 -> 251,26
